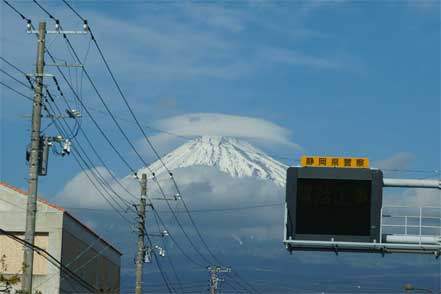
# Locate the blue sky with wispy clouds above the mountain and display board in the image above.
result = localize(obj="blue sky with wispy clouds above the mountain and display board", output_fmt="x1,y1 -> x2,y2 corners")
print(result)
0,1 -> 441,287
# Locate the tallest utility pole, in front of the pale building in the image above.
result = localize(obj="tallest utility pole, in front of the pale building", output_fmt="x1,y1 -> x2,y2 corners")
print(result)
22,21 -> 46,294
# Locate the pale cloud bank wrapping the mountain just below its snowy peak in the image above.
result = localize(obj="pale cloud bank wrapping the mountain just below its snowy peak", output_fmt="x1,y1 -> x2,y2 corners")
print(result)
55,163 -> 284,244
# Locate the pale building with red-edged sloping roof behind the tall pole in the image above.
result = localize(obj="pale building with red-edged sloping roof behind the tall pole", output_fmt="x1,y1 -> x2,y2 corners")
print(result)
0,182 -> 120,294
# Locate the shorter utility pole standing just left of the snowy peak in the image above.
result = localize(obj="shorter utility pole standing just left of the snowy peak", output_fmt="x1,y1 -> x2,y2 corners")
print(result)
135,174 -> 147,294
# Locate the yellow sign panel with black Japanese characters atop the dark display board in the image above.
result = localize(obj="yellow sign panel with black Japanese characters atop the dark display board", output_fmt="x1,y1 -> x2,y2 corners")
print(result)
300,156 -> 369,168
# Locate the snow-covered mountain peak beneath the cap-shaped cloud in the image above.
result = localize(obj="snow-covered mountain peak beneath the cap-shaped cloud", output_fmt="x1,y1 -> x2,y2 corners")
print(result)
138,136 -> 287,186
